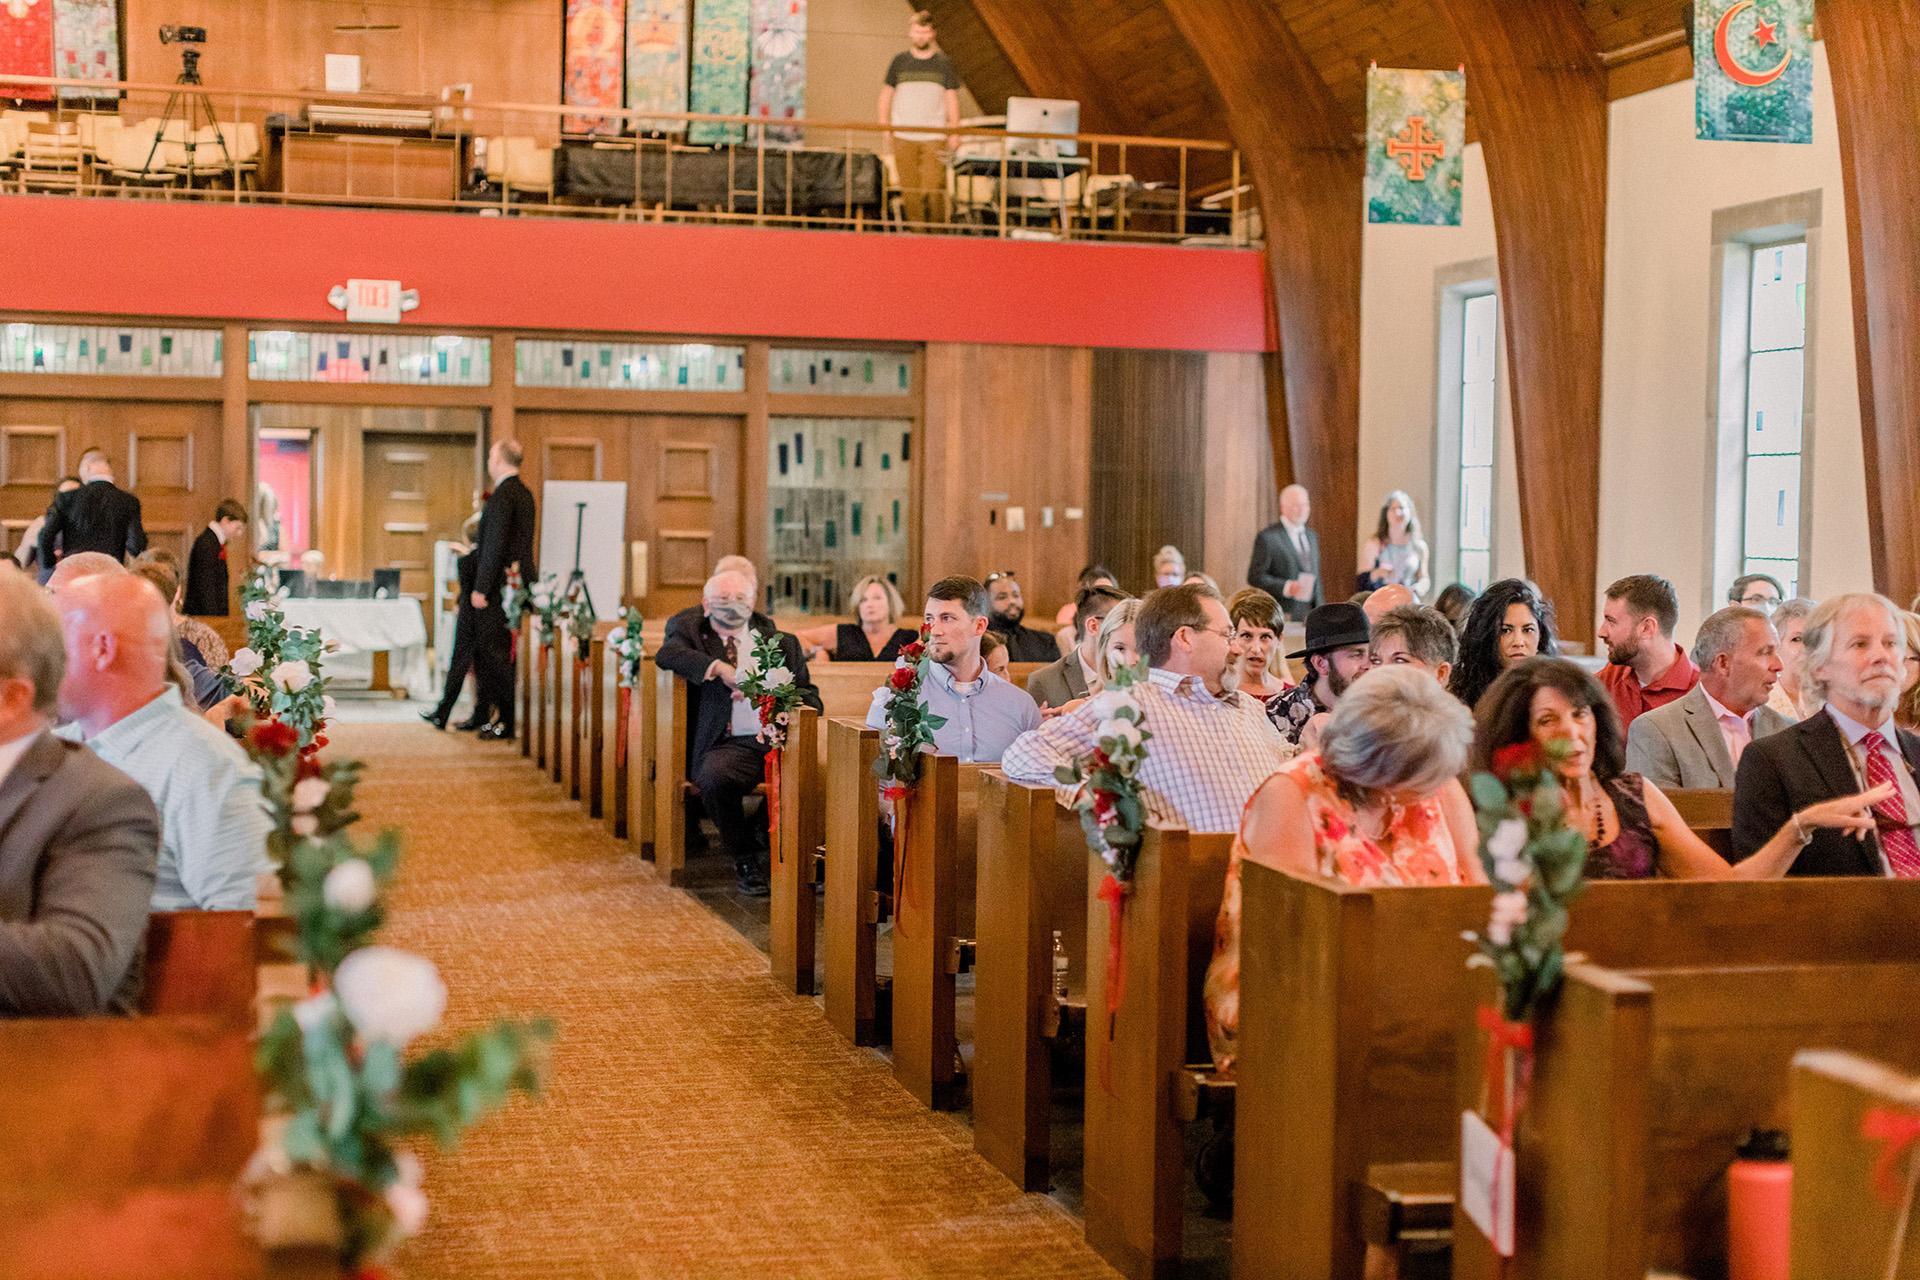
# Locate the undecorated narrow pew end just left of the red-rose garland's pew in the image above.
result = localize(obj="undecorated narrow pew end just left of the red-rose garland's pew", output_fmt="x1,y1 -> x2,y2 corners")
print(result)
822,720 -> 879,1044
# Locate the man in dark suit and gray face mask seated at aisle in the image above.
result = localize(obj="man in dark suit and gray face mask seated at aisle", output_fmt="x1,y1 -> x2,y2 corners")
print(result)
655,570 -> 820,896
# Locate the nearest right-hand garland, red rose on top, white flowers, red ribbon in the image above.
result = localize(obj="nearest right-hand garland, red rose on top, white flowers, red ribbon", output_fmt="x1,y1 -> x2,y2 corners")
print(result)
1465,741 -> 1586,1249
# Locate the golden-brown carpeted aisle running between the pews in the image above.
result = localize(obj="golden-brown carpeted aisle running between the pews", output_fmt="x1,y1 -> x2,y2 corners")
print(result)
332,725 -> 1112,1280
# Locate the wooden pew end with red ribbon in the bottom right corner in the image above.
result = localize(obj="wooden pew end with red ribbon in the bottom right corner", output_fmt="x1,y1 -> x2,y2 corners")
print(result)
1789,1050 -> 1920,1280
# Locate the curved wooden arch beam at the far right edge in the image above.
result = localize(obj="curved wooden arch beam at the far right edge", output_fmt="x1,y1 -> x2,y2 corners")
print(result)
1820,0 -> 1920,606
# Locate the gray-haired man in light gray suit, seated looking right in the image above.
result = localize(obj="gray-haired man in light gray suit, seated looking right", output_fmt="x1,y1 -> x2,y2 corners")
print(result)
1626,604 -> 1791,789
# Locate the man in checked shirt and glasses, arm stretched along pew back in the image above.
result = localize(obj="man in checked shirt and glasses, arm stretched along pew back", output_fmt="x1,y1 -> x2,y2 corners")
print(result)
1000,583 -> 1294,831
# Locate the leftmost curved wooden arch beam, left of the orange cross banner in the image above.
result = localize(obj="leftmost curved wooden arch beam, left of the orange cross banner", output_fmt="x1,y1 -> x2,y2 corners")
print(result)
1162,0 -> 1365,583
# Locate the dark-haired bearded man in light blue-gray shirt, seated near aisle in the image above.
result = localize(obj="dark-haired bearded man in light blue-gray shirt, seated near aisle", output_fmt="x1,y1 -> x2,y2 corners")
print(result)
866,576 -> 1054,764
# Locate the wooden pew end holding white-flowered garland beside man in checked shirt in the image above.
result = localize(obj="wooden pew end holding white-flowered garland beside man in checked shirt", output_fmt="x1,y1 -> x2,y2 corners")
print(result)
1081,827 -> 1228,1278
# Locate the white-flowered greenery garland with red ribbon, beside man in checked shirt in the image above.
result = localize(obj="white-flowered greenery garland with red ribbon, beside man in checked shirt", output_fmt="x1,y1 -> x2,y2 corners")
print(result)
1054,658 -> 1154,1092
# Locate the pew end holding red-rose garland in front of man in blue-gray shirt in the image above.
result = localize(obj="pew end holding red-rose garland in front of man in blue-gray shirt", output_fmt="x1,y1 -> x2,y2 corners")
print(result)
891,754 -> 981,1109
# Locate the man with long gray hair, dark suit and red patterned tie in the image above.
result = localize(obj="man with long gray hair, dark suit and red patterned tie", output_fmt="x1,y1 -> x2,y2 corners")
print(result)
1734,593 -> 1920,879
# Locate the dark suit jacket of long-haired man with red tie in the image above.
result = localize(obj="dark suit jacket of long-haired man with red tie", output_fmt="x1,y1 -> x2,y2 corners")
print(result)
1734,710 -> 1920,875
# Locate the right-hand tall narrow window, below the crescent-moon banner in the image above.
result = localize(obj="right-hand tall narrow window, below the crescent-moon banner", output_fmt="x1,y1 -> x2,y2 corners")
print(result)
1740,240 -> 1807,597
